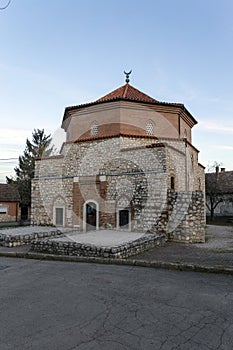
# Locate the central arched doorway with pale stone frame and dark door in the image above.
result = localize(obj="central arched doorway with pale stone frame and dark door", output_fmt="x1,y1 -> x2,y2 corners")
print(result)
84,201 -> 99,231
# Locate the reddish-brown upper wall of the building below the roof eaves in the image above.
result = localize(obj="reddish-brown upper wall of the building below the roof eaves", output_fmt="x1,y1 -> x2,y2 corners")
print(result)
62,101 -> 191,142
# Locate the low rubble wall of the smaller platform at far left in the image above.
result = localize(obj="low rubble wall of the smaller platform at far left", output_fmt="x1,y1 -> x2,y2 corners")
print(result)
0,228 -> 62,247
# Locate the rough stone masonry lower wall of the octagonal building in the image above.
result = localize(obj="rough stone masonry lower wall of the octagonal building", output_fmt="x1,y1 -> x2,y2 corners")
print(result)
32,137 -> 205,242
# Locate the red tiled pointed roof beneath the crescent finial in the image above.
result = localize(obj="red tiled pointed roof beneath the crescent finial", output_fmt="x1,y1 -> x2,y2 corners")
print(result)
96,84 -> 157,102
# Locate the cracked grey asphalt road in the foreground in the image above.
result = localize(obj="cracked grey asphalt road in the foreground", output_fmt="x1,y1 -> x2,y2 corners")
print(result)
0,257 -> 233,350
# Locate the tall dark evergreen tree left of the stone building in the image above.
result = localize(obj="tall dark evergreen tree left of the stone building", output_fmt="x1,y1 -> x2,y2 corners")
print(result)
6,129 -> 53,211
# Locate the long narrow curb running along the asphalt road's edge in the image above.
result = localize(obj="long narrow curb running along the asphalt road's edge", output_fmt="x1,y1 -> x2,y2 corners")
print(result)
0,252 -> 233,275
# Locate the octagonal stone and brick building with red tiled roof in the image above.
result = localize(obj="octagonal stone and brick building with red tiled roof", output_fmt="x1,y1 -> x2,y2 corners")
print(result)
31,77 -> 205,242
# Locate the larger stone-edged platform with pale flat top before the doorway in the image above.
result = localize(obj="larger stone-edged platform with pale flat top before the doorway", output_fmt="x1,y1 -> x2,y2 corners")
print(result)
31,230 -> 165,258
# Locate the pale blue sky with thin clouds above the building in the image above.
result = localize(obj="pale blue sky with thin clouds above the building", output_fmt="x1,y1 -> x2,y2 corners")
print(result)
0,0 -> 233,182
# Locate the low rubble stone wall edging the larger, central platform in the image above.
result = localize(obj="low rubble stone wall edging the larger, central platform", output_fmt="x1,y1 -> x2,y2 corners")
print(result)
31,234 -> 166,259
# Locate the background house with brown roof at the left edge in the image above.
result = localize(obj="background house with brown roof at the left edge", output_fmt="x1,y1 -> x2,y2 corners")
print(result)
0,184 -> 21,224
